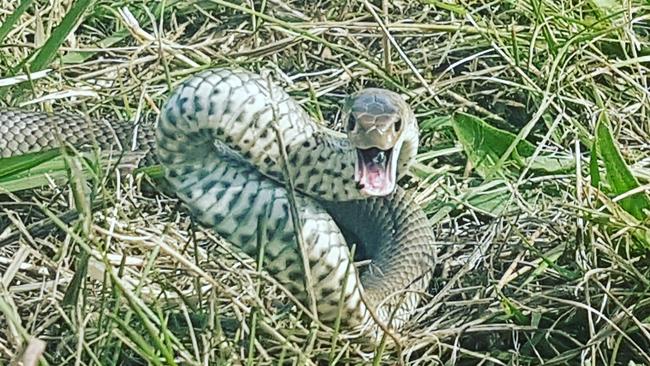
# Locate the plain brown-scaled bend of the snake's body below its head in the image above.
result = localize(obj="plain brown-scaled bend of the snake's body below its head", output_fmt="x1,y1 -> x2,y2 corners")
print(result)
322,187 -> 437,326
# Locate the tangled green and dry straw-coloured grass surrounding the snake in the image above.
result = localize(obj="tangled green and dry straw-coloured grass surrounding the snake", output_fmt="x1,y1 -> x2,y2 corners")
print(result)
0,0 -> 650,365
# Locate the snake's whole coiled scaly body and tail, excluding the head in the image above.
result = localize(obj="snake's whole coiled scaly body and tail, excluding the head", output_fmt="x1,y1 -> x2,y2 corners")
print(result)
0,69 -> 435,338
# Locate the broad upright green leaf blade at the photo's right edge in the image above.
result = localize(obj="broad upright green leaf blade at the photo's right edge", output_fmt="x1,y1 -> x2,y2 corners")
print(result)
592,112 -> 650,220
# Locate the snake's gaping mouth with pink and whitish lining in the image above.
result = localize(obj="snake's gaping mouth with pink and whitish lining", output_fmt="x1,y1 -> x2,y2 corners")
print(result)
354,147 -> 397,196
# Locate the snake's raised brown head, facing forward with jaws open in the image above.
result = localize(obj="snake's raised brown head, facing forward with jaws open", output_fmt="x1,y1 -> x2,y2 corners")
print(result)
343,88 -> 417,196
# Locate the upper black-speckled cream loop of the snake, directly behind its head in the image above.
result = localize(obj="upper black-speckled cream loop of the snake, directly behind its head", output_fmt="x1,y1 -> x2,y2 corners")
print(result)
158,71 -> 372,201
